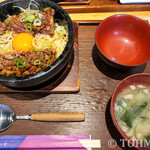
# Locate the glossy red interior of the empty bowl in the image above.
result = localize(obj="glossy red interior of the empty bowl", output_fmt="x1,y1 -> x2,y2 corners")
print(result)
96,15 -> 150,65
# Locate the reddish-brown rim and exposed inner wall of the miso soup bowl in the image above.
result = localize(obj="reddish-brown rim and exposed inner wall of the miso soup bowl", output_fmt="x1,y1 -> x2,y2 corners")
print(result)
111,73 -> 150,147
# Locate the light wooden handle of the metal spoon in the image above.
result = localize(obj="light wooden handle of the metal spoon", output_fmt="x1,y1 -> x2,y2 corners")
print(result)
31,113 -> 85,121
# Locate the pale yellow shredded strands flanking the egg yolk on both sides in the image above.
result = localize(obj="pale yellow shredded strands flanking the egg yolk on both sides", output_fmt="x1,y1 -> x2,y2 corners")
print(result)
0,23 -> 68,58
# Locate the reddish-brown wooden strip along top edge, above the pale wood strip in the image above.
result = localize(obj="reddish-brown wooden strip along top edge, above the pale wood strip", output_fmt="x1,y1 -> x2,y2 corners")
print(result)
62,0 -> 150,13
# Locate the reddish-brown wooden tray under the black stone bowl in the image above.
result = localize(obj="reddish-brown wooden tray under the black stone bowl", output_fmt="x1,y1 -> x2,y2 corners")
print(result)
0,22 -> 80,93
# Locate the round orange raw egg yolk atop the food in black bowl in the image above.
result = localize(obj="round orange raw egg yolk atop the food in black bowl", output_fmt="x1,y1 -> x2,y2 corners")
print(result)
12,33 -> 34,52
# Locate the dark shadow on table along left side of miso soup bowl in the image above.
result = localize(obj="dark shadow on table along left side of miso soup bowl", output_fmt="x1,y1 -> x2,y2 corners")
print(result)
105,98 -> 137,150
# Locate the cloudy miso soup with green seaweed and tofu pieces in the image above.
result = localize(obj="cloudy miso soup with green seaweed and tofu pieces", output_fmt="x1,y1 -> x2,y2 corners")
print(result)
114,85 -> 150,140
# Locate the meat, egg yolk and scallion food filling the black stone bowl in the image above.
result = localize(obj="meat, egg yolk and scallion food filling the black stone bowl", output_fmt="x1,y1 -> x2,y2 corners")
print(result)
0,7 -> 68,76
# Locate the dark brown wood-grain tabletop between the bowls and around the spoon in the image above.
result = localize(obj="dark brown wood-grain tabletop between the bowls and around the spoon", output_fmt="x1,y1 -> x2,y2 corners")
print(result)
0,24 -> 150,150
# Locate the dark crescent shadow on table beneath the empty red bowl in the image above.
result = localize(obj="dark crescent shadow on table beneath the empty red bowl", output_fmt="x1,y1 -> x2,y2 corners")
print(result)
92,44 -> 146,80
